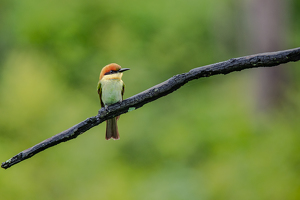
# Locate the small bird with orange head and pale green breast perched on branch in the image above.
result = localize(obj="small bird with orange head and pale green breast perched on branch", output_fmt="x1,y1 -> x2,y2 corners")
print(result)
97,63 -> 130,140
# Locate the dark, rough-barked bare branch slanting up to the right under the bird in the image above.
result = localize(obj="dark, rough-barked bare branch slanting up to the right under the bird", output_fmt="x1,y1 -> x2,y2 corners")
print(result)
1,48 -> 300,169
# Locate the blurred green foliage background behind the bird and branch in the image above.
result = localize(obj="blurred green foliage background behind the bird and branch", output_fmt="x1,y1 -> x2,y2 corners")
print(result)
0,0 -> 300,200
